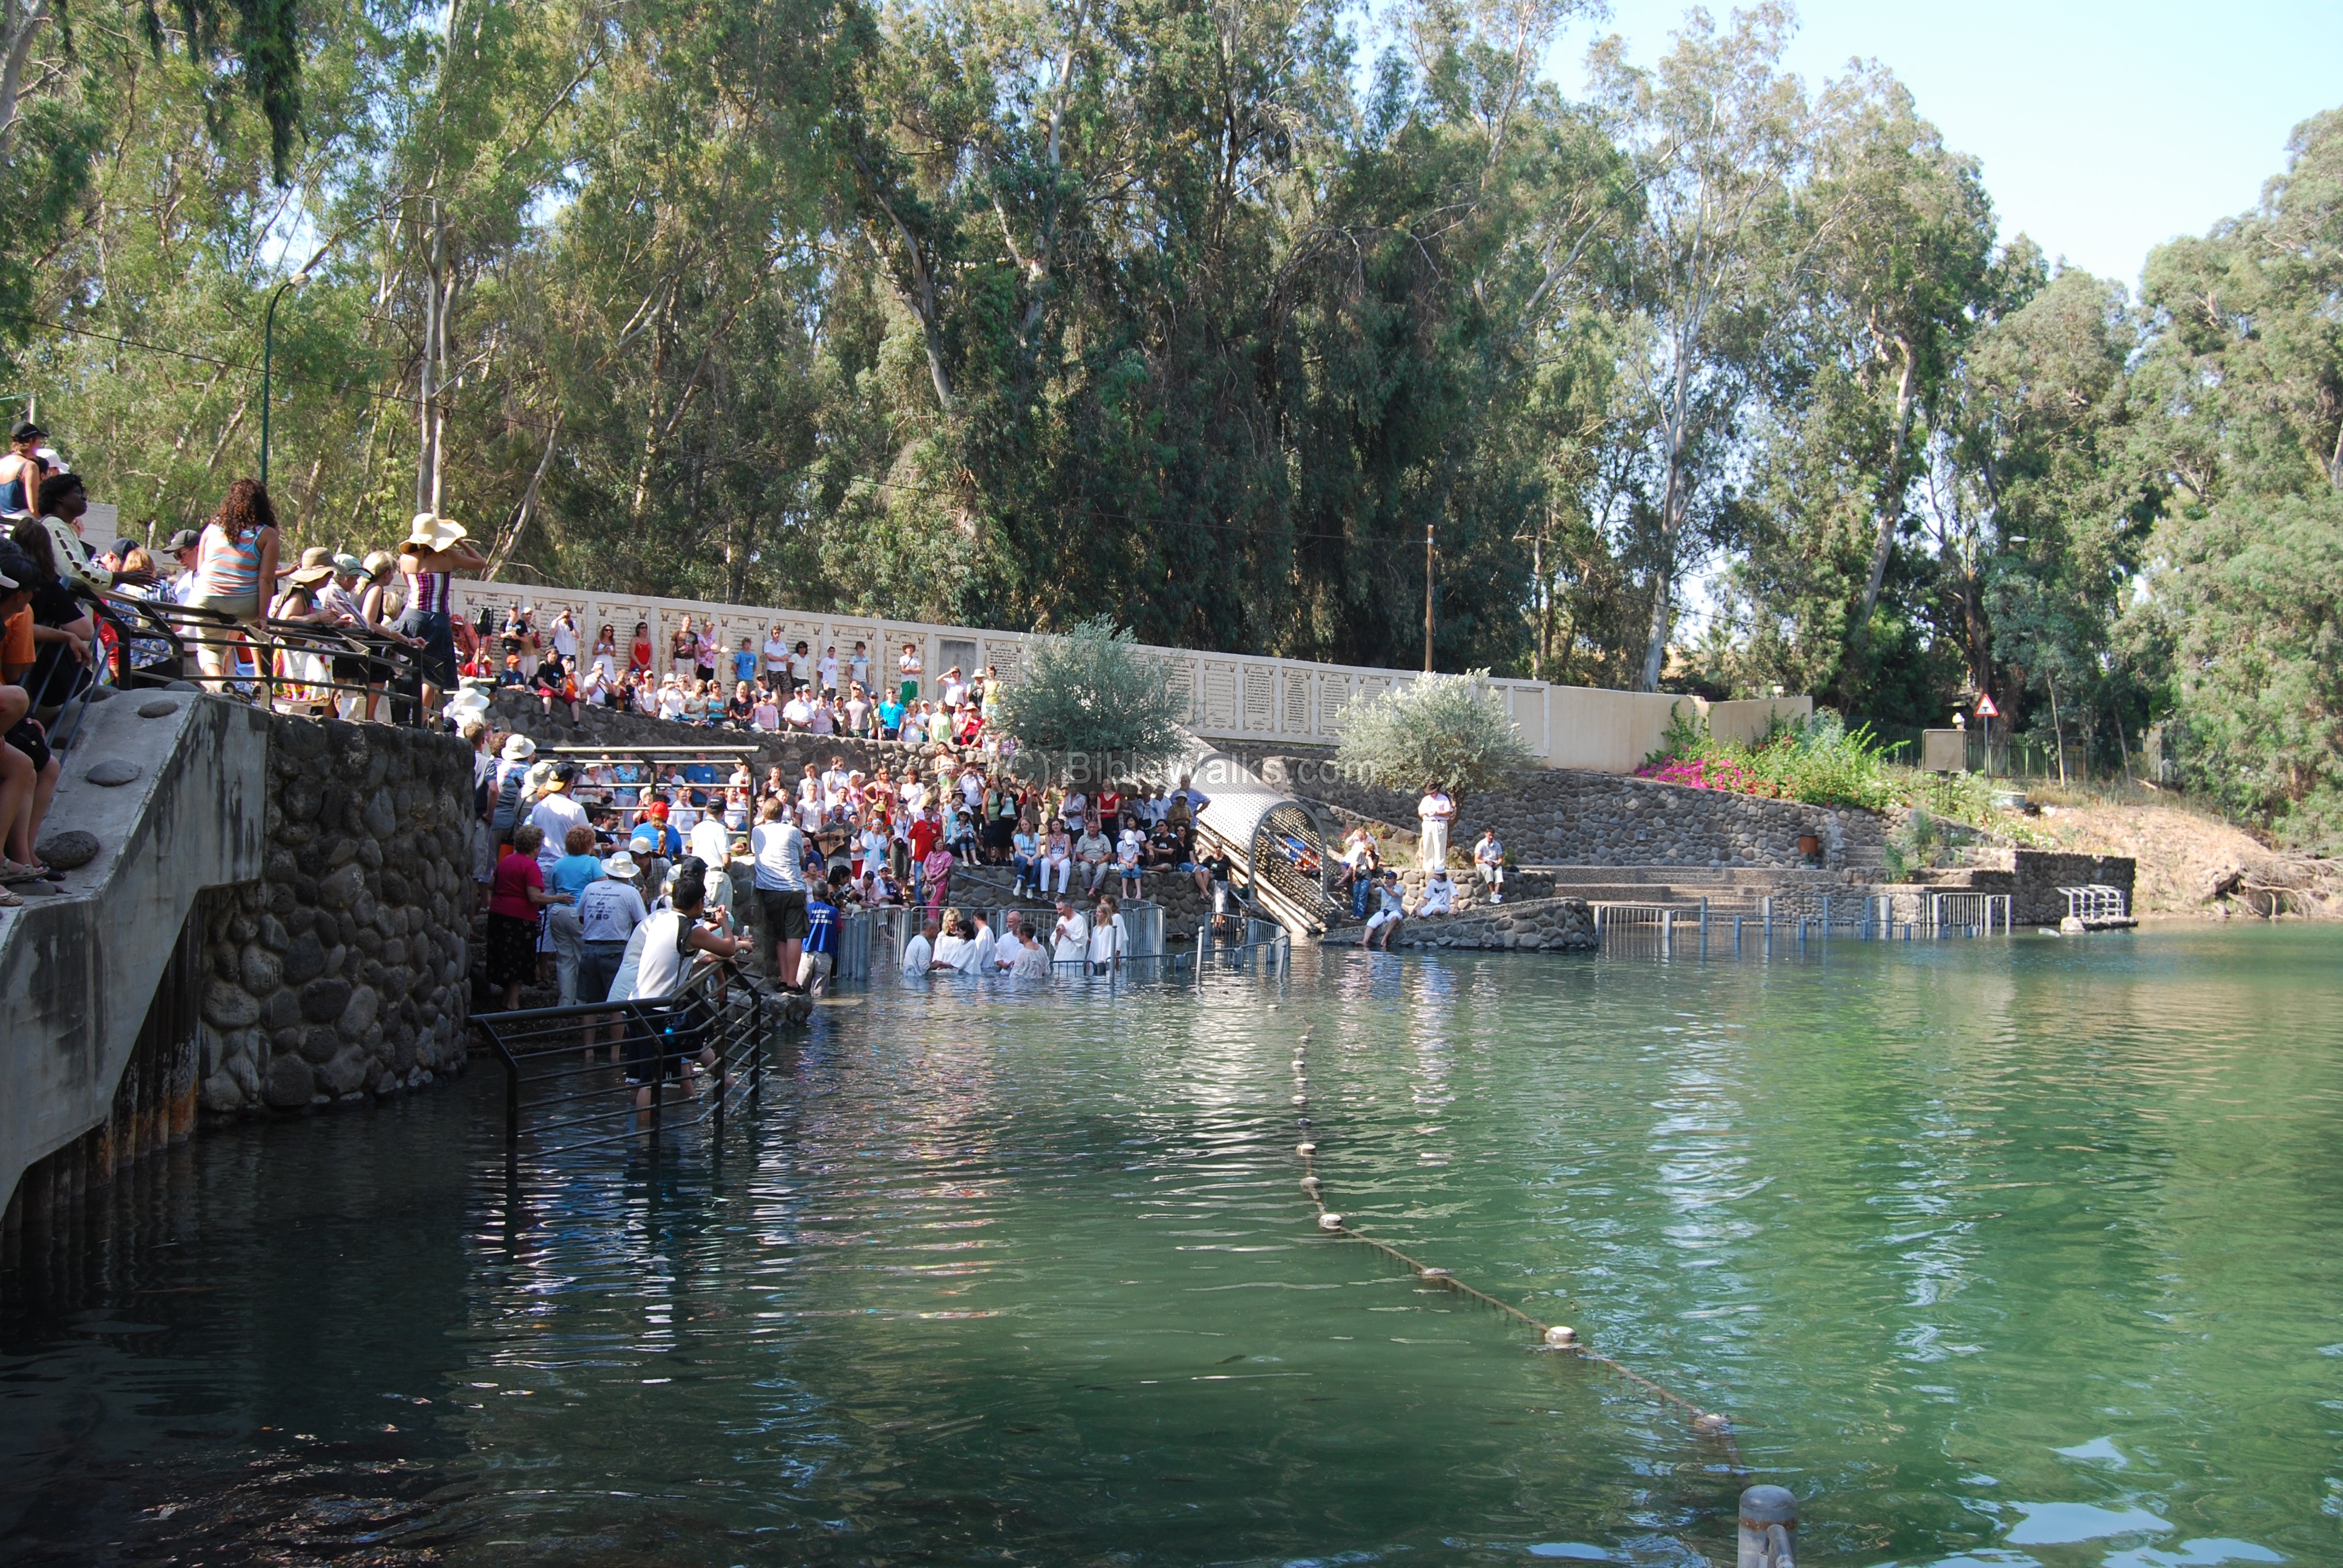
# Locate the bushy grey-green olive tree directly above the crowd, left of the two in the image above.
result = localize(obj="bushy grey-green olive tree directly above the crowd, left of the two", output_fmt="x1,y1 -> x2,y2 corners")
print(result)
998,616 -> 1188,783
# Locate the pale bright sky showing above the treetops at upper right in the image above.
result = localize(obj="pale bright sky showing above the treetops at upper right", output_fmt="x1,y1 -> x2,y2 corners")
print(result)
1553,0 -> 2343,286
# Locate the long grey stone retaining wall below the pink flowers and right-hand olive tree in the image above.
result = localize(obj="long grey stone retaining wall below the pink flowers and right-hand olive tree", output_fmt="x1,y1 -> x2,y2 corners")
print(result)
1258,755 -> 1886,867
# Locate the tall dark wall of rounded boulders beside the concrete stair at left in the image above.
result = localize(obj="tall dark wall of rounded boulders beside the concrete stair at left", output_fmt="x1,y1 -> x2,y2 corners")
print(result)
199,715 -> 473,1113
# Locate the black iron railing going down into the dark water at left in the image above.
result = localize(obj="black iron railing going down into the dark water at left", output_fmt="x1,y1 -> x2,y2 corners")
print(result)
471,961 -> 768,1148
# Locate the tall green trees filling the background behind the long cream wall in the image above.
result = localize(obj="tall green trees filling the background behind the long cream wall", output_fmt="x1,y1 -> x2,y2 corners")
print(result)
13,0 -> 2343,841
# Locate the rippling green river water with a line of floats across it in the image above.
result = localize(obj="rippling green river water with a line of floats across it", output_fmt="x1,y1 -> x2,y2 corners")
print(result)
0,928 -> 2343,1568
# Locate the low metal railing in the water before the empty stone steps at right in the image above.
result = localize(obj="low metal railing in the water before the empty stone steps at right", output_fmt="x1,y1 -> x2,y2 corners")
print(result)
1593,893 -> 2010,956
